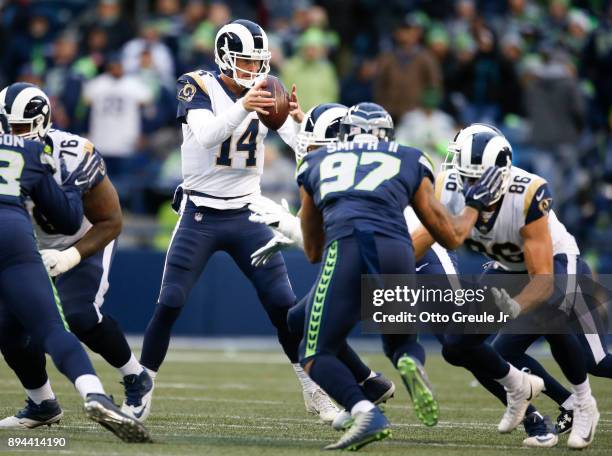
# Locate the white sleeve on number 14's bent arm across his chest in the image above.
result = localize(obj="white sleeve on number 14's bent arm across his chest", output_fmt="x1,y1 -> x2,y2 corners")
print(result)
187,104 -> 248,148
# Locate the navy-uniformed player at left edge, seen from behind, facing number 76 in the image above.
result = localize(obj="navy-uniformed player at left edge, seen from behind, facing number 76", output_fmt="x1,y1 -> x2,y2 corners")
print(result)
0,107 -> 150,442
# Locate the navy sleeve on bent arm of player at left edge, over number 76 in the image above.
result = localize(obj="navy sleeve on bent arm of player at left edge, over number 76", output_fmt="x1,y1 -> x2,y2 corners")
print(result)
30,173 -> 83,235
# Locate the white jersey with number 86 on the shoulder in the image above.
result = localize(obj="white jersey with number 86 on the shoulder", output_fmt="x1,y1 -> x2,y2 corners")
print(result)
436,166 -> 580,271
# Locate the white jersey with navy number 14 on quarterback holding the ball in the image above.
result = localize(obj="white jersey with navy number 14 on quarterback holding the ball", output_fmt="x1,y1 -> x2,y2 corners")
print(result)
178,71 -> 297,209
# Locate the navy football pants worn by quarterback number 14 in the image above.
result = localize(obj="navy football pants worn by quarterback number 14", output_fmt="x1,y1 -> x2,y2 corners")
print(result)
140,201 -> 299,371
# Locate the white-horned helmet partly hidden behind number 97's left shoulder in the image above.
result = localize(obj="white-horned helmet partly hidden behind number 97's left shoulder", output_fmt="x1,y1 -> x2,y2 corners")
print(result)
295,103 -> 348,162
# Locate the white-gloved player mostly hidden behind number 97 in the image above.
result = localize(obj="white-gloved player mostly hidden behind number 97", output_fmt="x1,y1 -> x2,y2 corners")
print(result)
249,103 -> 444,429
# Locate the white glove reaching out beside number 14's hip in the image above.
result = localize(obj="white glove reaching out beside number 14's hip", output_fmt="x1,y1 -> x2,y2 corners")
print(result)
249,196 -> 304,248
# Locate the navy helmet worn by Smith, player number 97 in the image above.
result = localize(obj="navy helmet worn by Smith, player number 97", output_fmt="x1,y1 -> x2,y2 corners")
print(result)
340,102 -> 395,141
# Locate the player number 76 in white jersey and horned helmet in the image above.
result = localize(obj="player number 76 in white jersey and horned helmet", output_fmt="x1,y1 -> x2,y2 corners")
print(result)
0,82 -> 151,428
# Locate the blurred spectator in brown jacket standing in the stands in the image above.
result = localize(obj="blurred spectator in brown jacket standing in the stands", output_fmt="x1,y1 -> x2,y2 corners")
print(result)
374,14 -> 442,119
